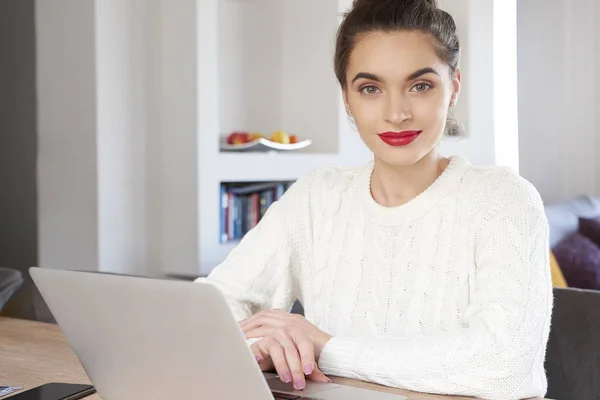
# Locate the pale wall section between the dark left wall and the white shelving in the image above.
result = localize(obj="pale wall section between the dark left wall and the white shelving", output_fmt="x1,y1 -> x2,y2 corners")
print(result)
36,0 -> 203,275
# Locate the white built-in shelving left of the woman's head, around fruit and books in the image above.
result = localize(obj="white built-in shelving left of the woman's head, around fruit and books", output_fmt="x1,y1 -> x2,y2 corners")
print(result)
190,0 -> 369,275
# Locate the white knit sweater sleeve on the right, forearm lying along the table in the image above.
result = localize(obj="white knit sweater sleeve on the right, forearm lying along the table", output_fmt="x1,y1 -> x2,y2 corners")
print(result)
319,178 -> 552,400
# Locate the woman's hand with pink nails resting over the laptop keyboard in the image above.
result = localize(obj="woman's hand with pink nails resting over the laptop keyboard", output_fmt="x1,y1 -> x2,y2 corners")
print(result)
240,310 -> 331,390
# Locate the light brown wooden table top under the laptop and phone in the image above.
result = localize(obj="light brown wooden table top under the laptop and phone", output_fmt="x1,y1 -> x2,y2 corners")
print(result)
0,317 -> 552,400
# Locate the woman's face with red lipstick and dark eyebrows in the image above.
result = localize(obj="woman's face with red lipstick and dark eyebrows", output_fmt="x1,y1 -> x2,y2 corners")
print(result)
344,32 -> 460,166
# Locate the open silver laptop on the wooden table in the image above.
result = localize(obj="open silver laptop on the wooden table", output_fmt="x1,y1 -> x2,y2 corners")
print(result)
30,267 -> 407,400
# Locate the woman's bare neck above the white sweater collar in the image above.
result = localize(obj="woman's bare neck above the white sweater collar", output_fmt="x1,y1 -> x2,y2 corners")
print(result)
371,150 -> 449,207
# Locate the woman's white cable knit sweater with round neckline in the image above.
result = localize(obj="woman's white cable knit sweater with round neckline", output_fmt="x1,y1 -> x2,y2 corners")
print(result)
202,156 -> 552,399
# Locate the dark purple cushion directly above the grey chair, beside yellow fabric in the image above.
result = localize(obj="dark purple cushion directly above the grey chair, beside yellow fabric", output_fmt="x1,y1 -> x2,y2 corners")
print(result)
554,233 -> 600,290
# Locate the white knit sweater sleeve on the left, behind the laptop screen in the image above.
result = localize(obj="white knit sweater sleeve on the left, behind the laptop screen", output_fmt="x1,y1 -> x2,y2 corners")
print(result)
196,176 -> 309,321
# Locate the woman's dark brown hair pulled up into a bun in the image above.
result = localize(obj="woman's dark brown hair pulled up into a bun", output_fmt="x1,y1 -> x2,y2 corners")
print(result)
334,0 -> 462,136
